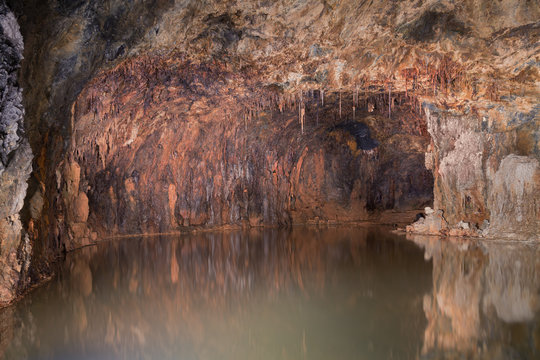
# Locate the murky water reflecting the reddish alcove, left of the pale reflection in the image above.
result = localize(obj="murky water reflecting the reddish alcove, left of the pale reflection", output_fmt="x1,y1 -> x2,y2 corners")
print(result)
0,228 -> 431,359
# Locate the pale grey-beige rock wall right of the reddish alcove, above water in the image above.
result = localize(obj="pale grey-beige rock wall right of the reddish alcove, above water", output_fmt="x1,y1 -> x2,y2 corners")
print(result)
425,105 -> 540,239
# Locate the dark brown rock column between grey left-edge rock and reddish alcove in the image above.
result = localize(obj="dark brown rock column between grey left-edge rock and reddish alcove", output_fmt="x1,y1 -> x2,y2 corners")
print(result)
7,0 -> 175,270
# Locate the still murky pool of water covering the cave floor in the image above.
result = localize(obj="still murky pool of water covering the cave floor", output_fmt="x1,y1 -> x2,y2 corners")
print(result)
0,227 -> 540,359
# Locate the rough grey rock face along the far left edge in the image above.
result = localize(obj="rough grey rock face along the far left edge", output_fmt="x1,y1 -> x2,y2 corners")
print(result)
0,2 -> 32,305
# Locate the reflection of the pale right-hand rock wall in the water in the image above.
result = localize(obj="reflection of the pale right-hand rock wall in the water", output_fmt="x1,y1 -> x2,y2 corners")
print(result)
408,236 -> 540,359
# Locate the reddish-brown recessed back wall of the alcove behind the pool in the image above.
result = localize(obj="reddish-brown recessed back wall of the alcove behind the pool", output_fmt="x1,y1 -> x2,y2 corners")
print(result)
52,57 -> 432,247
